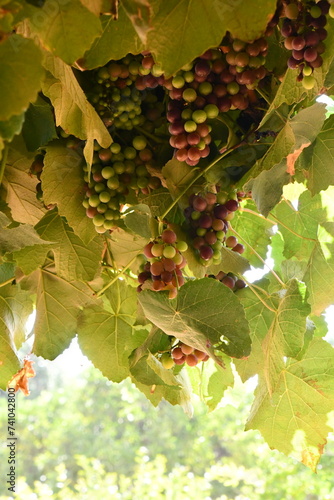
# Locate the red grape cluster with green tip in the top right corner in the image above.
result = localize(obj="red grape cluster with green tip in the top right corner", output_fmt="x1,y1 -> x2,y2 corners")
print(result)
281,0 -> 330,89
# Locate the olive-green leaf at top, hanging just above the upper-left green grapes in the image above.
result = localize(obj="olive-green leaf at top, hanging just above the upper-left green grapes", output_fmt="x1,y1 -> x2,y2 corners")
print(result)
83,3 -> 144,69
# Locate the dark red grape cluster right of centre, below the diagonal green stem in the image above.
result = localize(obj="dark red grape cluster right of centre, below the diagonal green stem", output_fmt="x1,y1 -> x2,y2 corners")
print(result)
184,192 -> 244,266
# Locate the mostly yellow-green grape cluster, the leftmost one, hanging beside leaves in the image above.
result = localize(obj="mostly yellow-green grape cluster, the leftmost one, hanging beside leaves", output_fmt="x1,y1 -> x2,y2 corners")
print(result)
82,136 -> 161,233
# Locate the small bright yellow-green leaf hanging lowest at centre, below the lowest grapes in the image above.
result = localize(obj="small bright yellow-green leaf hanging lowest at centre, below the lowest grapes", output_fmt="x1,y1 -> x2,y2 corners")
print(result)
188,355 -> 234,411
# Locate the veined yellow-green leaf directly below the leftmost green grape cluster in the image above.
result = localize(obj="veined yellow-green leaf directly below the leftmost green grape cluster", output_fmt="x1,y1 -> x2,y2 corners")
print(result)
36,210 -> 103,281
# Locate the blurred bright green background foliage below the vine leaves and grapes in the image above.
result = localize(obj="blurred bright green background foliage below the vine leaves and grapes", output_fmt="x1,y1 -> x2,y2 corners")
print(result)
0,348 -> 334,500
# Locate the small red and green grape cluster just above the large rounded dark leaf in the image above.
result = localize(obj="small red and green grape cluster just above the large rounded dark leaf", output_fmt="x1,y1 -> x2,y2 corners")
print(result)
137,229 -> 188,299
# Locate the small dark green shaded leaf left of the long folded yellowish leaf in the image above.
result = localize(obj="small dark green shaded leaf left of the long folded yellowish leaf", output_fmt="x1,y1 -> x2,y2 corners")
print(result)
22,97 -> 58,151
